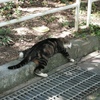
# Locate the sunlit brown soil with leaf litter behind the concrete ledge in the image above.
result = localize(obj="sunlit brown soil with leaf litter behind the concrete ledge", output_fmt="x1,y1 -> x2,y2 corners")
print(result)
0,0 -> 100,65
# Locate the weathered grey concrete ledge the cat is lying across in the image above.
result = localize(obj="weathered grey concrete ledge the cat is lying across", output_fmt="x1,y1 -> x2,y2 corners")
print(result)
0,36 -> 100,93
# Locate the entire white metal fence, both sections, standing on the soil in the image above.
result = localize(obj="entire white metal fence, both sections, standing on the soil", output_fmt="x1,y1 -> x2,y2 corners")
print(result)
0,0 -> 99,31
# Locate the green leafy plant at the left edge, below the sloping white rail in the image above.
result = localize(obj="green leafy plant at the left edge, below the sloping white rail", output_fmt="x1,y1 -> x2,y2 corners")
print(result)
0,28 -> 14,45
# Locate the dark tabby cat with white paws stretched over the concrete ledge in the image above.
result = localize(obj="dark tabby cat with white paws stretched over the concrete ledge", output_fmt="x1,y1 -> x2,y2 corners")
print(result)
8,38 -> 74,77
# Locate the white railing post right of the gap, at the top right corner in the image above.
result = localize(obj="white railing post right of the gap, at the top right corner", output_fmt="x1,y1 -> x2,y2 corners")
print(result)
86,0 -> 99,27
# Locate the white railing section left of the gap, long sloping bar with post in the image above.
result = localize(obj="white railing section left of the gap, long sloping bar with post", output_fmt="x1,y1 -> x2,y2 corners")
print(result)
0,0 -> 80,31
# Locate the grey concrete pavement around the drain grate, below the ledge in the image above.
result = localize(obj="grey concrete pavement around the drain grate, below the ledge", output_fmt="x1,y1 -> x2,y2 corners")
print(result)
0,51 -> 100,100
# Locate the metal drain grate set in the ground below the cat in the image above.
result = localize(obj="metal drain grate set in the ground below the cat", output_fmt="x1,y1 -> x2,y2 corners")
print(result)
0,66 -> 100,100
